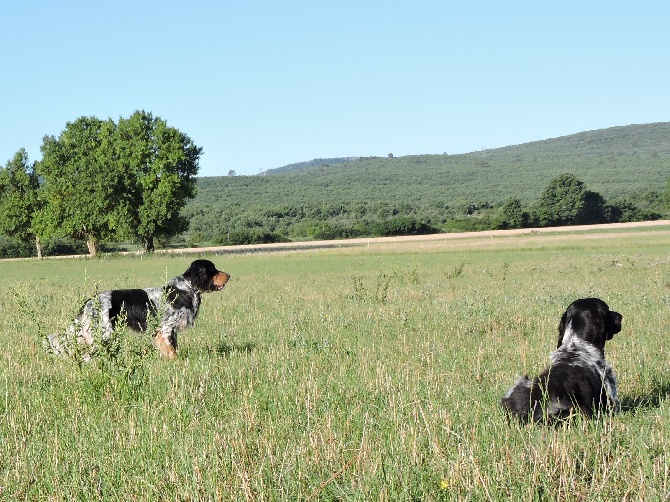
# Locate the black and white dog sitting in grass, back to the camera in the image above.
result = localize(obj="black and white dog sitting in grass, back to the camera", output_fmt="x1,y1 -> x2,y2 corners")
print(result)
501,298 -> 622,423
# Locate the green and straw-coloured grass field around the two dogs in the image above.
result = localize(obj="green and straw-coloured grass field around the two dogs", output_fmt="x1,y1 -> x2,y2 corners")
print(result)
0,228 -> 670,501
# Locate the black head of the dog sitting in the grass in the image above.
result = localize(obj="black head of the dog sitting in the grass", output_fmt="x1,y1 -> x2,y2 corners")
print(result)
558,298 -> 622,355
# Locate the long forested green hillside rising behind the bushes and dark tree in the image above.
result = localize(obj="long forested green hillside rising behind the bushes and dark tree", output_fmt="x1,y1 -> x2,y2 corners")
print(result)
184,122 -> 670,245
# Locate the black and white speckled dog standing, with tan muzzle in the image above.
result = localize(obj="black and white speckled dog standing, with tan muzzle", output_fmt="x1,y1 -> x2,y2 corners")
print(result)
47,260 -> 230,358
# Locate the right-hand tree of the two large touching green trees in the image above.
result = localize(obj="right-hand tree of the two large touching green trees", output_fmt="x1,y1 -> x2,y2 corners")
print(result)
116,111 -> 202,251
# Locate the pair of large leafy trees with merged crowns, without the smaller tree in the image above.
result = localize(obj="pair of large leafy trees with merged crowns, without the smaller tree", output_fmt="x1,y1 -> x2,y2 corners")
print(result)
36,111 -> 202,254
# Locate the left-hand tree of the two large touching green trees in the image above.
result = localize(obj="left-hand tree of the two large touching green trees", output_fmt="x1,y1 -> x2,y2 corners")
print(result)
37,117 -> 125,255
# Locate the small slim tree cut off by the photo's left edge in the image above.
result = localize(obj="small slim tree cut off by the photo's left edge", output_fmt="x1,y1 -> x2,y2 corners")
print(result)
0,148 -> 42,259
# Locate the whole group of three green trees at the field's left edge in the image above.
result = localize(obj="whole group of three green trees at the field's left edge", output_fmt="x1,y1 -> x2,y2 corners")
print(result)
0,111 -> 202,257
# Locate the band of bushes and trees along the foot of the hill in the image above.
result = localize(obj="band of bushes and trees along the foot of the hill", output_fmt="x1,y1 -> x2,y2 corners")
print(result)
185,173 -> 670,245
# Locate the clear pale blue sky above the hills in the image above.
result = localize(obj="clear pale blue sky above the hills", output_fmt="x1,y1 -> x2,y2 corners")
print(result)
0,0 -> 670,176
